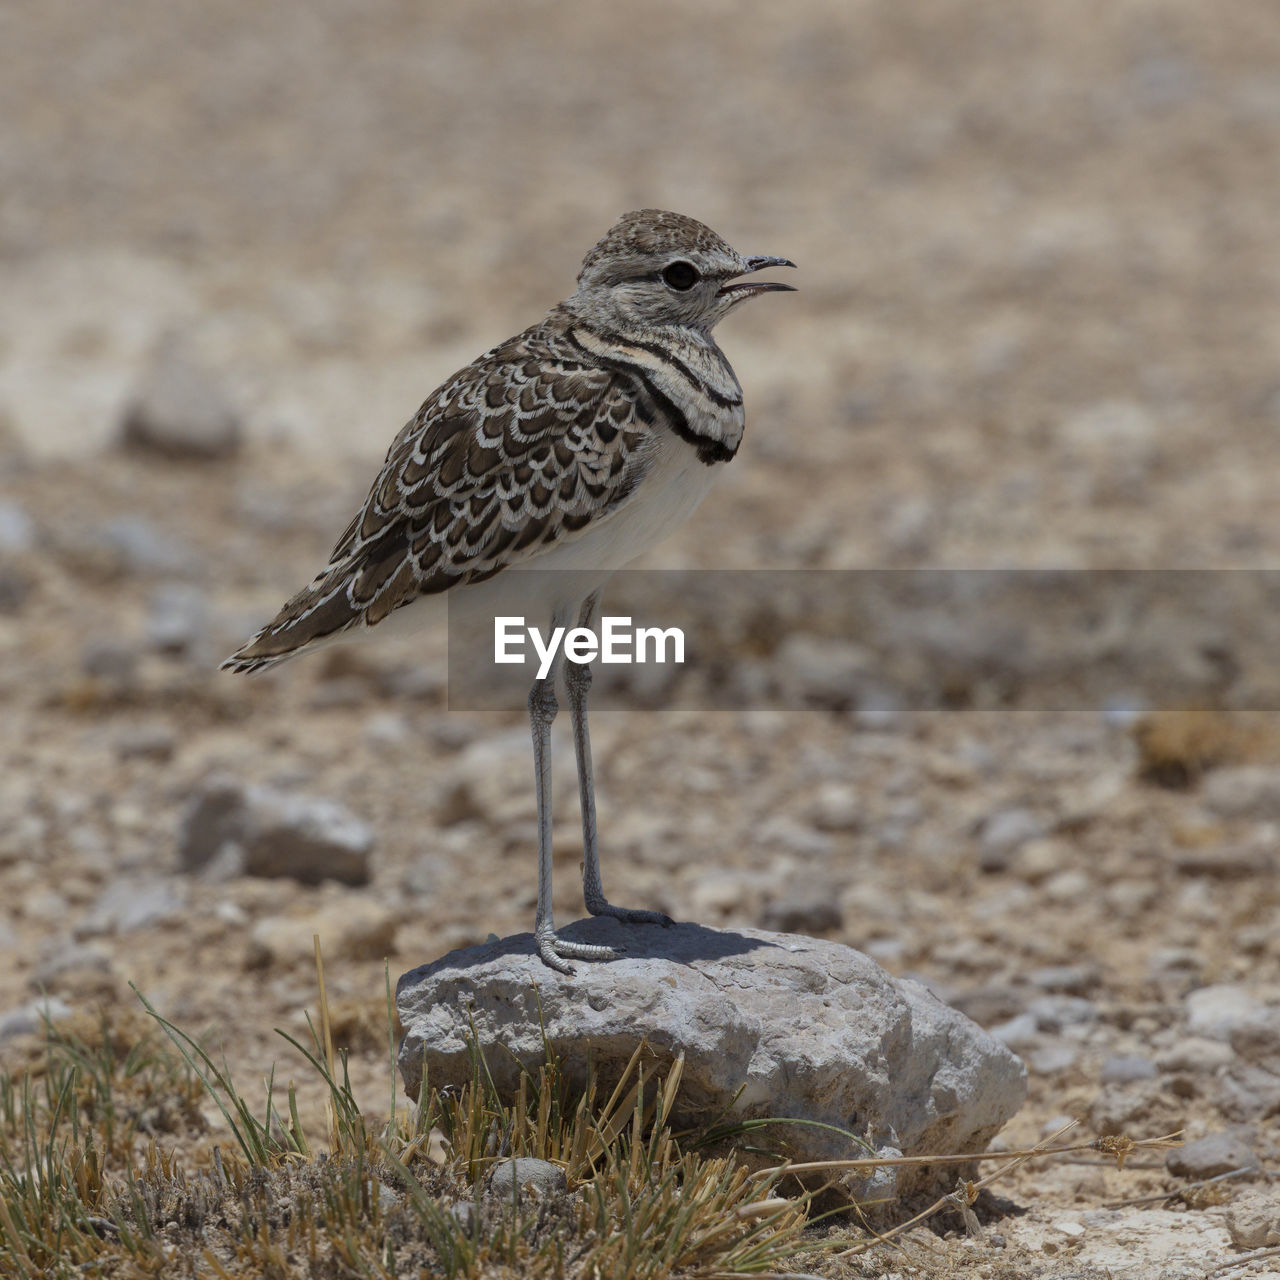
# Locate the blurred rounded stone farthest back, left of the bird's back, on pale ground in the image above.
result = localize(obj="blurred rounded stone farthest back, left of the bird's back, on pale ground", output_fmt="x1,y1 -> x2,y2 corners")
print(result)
120,337 -> 242,460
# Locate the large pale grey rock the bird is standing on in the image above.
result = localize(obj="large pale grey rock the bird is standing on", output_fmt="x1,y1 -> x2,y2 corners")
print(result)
397,919 -> 1027,1193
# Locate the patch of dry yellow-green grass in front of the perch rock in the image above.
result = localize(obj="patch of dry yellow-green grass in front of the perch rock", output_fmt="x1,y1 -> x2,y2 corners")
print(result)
0,956 -> 1192,1280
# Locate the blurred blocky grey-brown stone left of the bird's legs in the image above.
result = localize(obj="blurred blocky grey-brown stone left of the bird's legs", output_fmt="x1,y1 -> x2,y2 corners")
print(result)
178,776 -> 374,884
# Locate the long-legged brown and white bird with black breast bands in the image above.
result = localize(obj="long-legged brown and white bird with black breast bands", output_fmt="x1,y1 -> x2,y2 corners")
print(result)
221,209 -> 795,974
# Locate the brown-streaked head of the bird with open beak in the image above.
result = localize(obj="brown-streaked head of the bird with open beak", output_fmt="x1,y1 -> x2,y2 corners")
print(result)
570,209 -> 795,332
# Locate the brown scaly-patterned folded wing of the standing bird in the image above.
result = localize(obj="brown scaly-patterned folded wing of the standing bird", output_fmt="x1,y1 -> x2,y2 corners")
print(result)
223,326 -> 655,671
